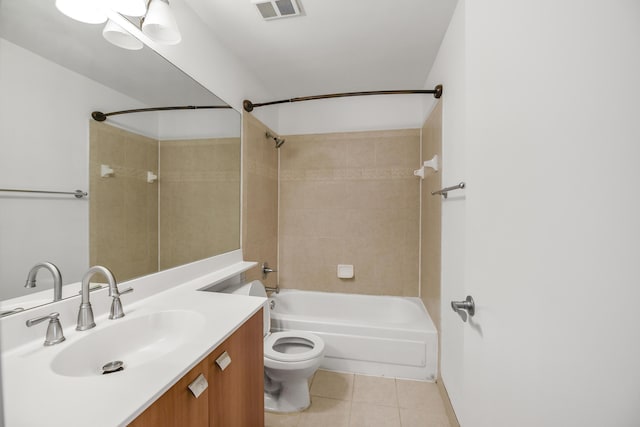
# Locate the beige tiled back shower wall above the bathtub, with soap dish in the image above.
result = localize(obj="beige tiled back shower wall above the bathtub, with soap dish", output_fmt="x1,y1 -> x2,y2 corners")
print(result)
279,129 -> 420,296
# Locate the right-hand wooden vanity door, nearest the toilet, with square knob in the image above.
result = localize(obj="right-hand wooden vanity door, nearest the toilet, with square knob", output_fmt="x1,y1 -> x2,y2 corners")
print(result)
208,310 -> 264,427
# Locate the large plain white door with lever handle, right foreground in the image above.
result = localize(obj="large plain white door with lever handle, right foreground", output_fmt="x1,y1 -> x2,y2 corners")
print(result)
434,0 -> 640,426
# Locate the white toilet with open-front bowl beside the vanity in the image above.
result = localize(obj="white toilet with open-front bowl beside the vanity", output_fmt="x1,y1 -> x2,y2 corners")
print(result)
231,280 -> 324,412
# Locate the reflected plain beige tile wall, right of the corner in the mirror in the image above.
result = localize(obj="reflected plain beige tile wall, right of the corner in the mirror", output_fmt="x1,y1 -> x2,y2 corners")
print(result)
160,138 -> 240,269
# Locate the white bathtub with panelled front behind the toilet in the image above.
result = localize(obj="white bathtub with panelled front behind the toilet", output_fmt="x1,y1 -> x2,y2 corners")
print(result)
270,289 -> 438,381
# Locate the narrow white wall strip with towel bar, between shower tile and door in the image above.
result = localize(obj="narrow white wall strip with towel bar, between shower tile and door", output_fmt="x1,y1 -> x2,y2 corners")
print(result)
423,0 -> 473,422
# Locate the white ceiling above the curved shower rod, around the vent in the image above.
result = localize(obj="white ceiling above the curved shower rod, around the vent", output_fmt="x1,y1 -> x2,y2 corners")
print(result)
185,0 -> 457,102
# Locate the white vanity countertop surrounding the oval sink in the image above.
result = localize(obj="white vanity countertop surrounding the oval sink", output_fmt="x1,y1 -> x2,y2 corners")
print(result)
2,258 -> 264,427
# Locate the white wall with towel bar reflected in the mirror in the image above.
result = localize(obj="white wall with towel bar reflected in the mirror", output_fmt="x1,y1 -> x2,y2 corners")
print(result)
0,39 -> 157,299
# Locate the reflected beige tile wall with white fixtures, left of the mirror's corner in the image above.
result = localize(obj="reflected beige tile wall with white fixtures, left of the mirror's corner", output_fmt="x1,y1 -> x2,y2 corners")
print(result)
89,121 -> 158,281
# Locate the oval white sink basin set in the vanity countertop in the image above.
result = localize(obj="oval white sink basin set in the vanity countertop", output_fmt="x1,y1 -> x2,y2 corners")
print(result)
51,310 -> 204,377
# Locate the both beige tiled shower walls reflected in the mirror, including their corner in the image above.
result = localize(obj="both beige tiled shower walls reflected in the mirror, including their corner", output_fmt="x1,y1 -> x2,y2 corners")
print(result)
89,122 -> 240,281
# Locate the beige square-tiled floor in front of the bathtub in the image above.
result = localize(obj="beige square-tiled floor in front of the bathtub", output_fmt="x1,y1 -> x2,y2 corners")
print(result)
265,371 -> 450,427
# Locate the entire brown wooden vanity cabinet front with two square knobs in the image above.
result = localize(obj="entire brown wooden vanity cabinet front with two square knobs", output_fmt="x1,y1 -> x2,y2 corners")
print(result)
129,310 -> 264,427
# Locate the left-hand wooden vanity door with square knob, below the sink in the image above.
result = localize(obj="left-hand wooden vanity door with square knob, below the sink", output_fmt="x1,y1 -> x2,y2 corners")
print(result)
129,359 -> 209,427
